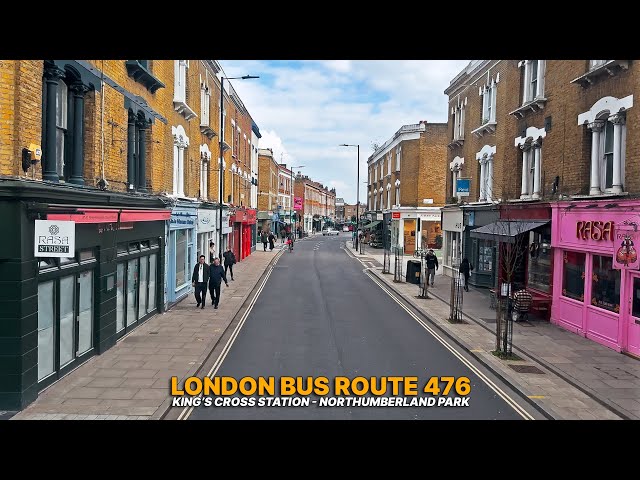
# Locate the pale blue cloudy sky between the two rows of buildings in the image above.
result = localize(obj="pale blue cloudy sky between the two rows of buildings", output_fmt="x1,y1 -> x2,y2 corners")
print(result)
219,60 -> 469,204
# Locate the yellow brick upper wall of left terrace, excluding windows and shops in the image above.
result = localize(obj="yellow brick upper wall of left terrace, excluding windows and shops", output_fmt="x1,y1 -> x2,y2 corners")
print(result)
0,60 -> 253,205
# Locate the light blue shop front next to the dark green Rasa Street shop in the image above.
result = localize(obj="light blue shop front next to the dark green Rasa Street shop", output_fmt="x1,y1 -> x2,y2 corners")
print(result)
167,202 -> 198,305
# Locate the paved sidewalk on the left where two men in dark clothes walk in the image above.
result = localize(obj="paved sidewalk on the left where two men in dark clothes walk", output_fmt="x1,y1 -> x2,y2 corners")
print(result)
11,236 -> 320,420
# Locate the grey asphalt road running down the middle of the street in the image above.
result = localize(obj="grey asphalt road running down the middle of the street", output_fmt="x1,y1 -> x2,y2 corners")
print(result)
189,233 -> 522,420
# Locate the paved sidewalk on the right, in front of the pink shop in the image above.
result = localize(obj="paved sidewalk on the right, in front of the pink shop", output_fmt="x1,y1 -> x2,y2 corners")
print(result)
345,241 -> 640,420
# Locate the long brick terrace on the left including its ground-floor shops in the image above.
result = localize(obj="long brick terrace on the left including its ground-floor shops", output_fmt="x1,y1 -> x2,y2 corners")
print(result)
0,60 -> 259,410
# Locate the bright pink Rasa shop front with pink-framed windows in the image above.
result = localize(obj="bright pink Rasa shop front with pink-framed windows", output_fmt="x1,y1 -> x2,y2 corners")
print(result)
551,198 -> 640,357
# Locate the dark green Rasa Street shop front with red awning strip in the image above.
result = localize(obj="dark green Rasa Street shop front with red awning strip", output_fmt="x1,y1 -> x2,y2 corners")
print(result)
0,180 -> 171,410
